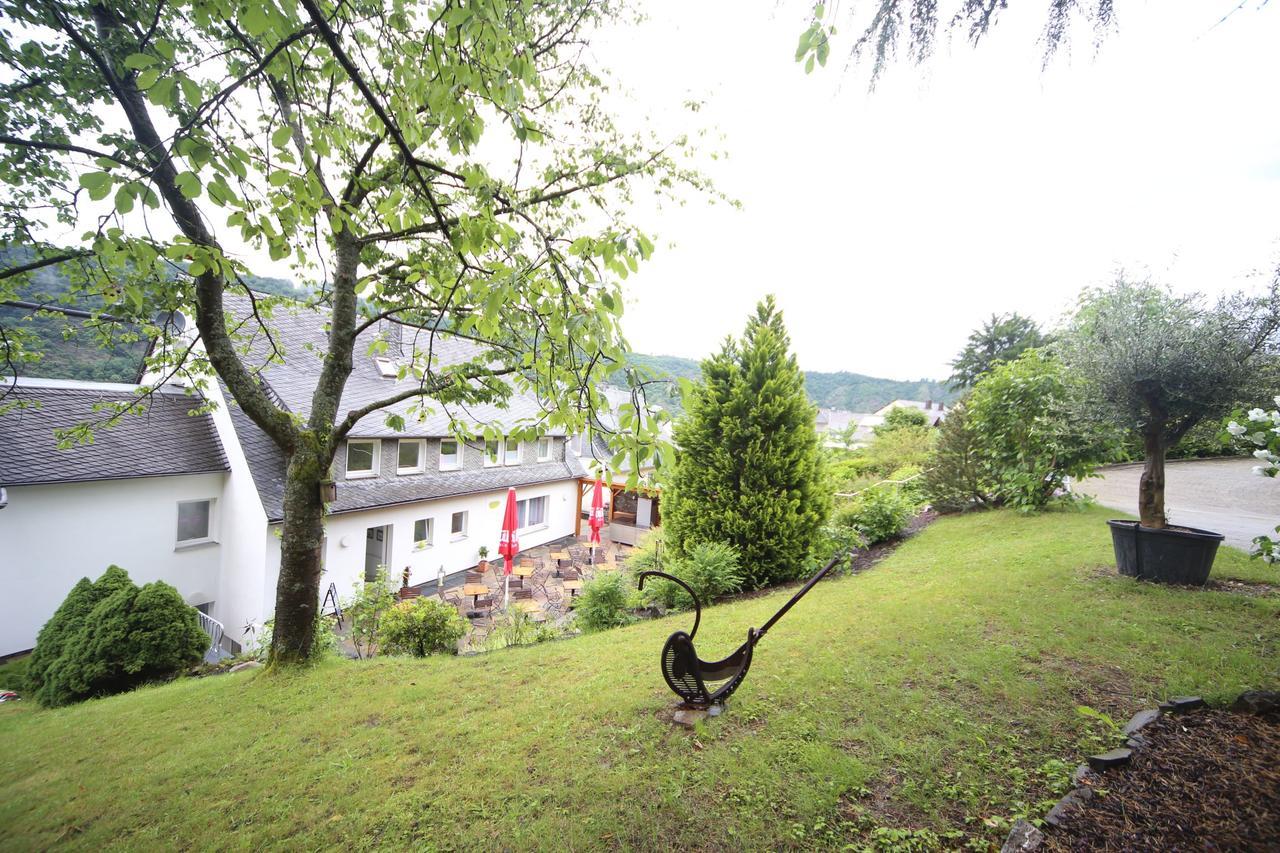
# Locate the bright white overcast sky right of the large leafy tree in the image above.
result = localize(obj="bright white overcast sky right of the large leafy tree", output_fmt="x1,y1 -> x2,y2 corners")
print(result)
593,0 -> 1280,379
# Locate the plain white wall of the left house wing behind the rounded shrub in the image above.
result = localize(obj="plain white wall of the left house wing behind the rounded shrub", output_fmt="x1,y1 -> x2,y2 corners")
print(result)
0,474 -> 227,654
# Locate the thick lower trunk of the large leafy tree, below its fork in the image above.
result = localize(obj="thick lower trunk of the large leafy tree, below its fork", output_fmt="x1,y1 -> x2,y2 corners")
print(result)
268,439 -> 329,667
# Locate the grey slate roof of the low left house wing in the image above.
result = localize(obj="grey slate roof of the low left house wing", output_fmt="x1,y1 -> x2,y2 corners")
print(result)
0,379 -> 228,487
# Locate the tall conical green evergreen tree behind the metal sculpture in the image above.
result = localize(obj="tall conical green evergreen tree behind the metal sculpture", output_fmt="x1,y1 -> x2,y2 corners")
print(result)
663,296 -> 831,587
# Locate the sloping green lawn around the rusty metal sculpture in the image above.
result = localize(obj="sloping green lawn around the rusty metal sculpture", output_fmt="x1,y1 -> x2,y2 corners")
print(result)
0,510 -> 1280,849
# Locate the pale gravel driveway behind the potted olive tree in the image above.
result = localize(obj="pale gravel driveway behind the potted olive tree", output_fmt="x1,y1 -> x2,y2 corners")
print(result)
1075,457 -> 1280,548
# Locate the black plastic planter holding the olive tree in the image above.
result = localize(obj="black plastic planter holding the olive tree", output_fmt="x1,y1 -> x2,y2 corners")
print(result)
1107,520 -> 1224,587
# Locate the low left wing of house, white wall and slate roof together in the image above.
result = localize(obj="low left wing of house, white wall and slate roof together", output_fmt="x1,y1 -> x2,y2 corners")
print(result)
0,379 -> 230,656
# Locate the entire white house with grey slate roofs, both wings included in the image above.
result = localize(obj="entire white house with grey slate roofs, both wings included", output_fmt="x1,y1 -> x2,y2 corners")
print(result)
0,295 -> 588,656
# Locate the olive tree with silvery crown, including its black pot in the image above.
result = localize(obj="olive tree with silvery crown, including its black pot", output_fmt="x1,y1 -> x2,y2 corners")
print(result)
1060,275 -> 1280,585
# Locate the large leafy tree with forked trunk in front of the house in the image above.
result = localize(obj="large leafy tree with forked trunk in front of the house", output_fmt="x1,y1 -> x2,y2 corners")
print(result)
0,0 -> 700,665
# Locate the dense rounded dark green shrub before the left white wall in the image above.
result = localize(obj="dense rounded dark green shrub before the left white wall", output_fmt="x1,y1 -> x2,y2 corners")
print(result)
31,566 -> 209,707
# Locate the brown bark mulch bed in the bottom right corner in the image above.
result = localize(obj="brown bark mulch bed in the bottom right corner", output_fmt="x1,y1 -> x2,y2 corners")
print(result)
1042,711 -> 1280,850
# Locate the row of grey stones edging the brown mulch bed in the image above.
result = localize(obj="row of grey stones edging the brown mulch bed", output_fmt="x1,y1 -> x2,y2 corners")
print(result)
1000,690 -> 1280,853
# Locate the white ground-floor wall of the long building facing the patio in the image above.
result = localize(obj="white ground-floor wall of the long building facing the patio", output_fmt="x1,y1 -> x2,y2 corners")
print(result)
307,480 -> 577,598
